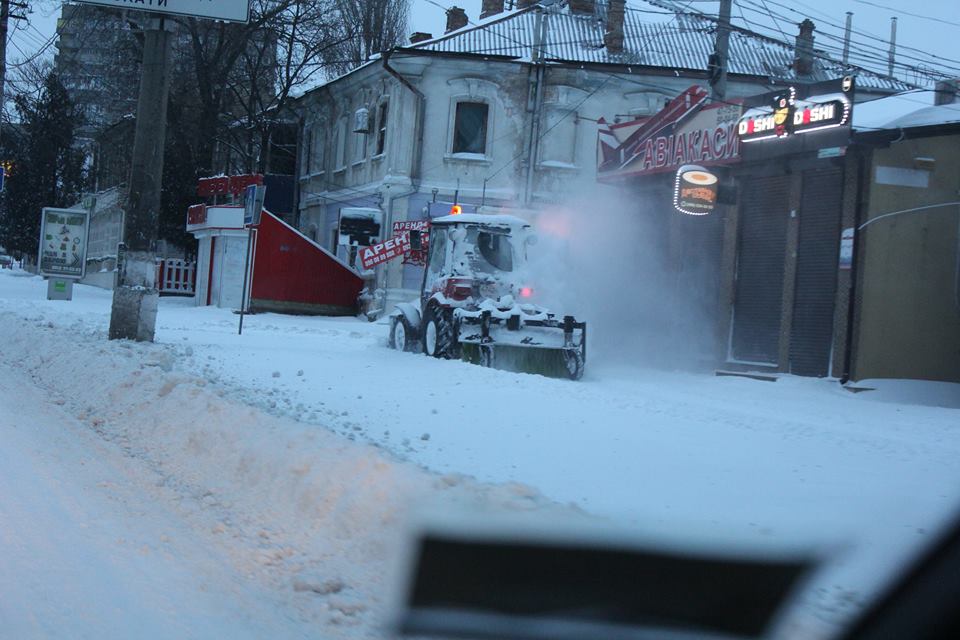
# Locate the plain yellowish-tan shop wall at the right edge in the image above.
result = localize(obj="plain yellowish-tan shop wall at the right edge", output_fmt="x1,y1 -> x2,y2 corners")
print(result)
853,134 -> 960,382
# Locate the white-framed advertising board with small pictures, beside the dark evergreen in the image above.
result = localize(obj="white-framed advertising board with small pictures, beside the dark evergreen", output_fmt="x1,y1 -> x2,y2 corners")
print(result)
37,207 -> 90,279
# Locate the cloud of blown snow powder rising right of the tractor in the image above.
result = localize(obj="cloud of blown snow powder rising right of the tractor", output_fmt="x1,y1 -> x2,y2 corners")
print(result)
529,193 -> 716,368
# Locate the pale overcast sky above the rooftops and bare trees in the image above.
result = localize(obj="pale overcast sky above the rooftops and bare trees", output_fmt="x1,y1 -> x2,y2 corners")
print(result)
7,0 -> 960,85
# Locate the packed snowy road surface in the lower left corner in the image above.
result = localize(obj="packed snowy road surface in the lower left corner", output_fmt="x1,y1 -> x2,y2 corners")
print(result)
0,366 -> 304,639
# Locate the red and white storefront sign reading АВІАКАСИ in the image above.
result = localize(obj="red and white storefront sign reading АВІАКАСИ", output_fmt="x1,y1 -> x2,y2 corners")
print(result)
597,85 -> 741,181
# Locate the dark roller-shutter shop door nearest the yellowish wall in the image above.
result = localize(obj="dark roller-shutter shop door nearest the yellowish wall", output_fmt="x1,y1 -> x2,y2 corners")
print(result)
790,169 -> 843,377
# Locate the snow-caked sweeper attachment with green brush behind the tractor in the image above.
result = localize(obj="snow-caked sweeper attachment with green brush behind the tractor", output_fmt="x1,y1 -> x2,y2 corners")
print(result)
460,312 -> 587,380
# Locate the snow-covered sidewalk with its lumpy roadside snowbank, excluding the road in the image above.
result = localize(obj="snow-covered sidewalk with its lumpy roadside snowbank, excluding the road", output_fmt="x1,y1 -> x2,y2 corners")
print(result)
0,272 -> 960,637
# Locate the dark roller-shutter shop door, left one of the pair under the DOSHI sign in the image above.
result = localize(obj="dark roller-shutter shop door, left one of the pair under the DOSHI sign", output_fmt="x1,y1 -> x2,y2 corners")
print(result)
730,176 -> 790,365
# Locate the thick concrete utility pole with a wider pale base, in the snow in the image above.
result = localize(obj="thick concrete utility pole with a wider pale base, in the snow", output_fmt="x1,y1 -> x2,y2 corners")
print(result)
109,16 -> 175,342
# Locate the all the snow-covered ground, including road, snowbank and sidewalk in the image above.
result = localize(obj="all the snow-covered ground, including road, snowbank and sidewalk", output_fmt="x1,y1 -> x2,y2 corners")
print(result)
0,271 -> 960,638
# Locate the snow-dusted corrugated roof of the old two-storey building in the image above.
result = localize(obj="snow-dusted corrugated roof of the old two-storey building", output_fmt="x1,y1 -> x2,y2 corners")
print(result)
408,0 -> 912,91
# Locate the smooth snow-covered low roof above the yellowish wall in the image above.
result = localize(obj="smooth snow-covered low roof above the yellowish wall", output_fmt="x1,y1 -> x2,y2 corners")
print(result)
853,91 -> 960,131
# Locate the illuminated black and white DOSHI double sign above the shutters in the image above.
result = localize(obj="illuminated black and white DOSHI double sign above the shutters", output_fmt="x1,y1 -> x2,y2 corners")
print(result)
737,77 -> 853,143
